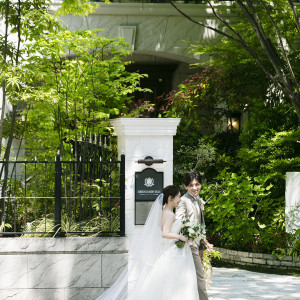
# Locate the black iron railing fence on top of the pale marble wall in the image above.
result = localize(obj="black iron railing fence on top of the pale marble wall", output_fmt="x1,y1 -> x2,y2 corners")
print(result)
0,155 -> 125,236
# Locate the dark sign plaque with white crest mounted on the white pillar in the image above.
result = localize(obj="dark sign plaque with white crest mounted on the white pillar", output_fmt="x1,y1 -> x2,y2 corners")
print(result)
135,168 -> 164,225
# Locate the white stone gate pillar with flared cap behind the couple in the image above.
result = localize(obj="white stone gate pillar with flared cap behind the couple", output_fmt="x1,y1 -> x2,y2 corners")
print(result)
111,118 -> 180,245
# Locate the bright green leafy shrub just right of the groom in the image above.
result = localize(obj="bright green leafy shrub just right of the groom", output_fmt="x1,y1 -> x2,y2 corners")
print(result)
202,169 -> 272,250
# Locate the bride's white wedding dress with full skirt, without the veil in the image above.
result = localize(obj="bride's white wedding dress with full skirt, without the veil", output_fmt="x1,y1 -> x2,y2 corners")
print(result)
127,220 -> 199,300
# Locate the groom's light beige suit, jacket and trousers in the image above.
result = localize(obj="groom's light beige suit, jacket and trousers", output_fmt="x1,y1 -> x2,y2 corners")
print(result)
176,193 -> 208,300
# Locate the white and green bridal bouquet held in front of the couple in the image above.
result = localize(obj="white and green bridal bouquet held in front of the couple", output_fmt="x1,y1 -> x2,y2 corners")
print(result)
175,219 -> 206,248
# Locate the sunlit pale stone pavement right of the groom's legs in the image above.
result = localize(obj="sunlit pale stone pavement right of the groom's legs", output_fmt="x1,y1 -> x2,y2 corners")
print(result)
208,268 -> 300,300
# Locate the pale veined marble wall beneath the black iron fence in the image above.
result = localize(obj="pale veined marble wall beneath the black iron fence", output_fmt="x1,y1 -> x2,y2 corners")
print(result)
0,237 -> 128,300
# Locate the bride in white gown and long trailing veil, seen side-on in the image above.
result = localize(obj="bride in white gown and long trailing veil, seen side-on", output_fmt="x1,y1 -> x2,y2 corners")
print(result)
96,185 -> 199,300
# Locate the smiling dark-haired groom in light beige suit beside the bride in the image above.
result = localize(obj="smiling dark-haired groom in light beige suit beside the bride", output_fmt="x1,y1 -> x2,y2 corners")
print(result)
176,171 -> 208,300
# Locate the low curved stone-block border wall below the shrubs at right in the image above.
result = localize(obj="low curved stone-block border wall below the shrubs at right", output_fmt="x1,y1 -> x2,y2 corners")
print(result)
215,247 -> 300,270
